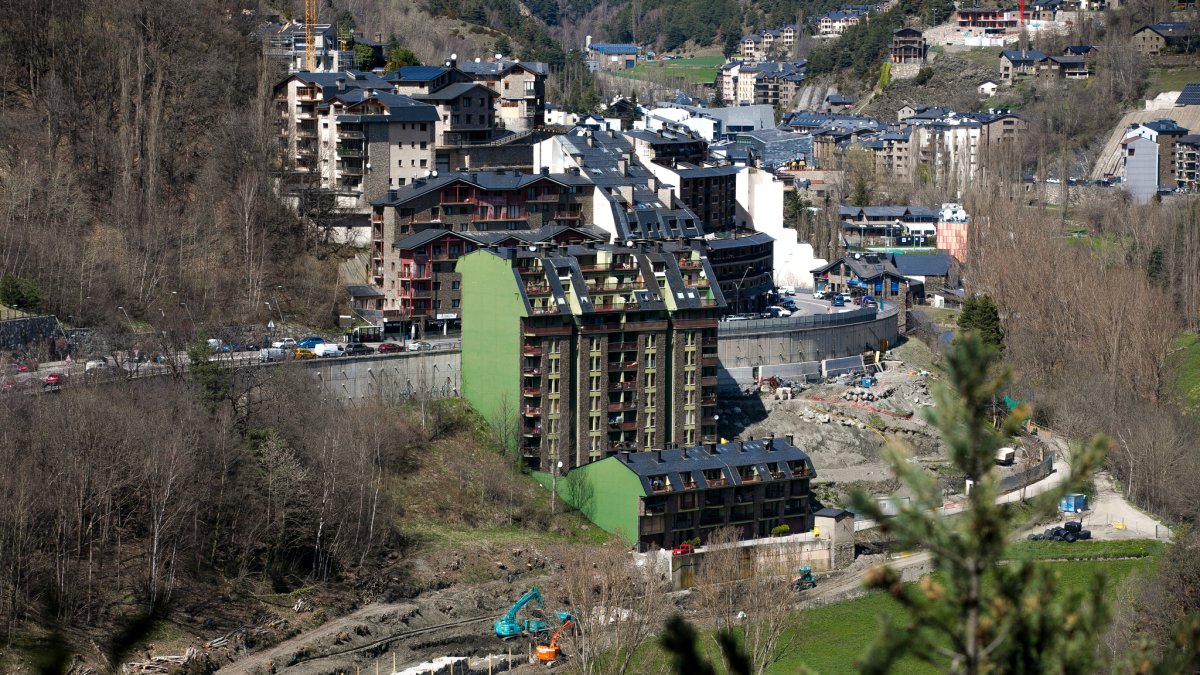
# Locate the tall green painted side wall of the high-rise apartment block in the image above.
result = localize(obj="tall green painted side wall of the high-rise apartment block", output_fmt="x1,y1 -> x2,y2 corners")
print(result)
455,251 -> 526,443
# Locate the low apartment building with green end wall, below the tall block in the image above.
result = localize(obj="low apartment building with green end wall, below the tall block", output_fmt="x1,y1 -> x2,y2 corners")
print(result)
563,436 -> 824,551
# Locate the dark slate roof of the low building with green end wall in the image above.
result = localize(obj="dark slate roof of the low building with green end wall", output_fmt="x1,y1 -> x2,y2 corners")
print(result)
614,437 -> 816,496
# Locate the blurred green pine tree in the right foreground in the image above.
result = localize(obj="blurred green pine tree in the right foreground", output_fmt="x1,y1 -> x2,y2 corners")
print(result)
851,331 -> 1109,675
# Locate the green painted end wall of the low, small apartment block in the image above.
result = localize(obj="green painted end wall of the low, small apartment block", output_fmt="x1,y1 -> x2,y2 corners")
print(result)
554,458 -> 646,545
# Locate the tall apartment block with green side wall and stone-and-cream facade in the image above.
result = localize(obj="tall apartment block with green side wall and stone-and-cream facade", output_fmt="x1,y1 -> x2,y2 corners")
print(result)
457,243 -> 725,471
